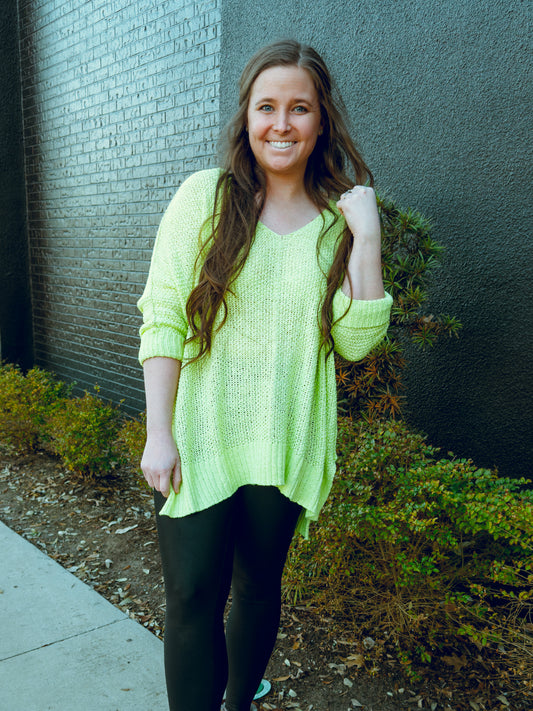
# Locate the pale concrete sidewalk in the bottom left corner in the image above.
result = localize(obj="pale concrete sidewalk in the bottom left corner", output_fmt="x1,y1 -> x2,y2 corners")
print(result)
0,523 -> 168,711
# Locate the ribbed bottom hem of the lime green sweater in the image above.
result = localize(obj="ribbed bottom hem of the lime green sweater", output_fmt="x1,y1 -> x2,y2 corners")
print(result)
159,442 -> 335,538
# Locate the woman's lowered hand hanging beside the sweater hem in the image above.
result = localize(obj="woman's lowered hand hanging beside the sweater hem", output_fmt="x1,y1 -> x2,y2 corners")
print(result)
141,432 -> 181,498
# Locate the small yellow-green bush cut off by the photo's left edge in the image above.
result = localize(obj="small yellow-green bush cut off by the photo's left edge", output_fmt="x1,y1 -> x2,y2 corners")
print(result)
0,363 -> 70,452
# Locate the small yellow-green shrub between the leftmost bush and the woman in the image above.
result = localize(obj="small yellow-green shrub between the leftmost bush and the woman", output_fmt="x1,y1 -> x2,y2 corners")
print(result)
48,388 -> 121,476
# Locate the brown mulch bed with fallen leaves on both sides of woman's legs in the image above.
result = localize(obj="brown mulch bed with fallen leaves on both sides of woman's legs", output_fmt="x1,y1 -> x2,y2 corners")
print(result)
0,452 -> 533,711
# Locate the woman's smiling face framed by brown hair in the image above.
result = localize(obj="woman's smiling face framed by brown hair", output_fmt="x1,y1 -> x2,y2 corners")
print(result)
247,66 -> 321,182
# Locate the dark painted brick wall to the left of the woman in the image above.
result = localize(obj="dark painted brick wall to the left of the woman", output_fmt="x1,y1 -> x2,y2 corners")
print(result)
19,0 -> 220,411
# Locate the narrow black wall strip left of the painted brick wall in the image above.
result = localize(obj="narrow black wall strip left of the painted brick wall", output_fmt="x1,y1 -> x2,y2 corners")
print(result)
0,2 -> 32,368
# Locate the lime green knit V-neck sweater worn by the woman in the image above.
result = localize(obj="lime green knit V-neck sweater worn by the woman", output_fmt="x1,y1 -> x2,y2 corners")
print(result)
138,170 -> 392,536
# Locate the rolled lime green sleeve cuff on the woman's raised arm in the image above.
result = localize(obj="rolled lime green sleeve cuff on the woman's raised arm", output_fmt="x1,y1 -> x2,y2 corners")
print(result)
331,289 -> 392,361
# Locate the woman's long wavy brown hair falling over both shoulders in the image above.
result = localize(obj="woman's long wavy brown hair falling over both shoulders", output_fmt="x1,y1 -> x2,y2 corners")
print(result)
186,40 -> 373,362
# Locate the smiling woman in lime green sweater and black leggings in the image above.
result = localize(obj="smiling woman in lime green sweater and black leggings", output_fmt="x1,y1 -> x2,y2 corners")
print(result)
139,41 -> 391,711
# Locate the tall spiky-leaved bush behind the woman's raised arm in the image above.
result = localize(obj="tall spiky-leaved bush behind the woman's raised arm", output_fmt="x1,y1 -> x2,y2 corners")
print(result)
336,196 -> 461,420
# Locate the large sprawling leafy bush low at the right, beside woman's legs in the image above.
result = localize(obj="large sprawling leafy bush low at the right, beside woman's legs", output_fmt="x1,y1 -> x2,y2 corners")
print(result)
285,418 -> 533,673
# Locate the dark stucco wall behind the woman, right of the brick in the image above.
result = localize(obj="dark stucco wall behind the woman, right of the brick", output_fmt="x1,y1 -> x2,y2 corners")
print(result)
221,0 -> 533,476
